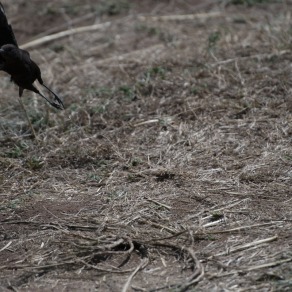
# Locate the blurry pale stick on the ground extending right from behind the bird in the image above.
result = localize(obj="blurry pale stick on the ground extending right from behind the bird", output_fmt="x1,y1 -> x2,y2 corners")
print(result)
20,21 -> 111,49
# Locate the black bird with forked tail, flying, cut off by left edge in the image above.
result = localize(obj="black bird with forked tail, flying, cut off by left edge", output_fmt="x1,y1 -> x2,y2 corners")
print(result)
0,2 -> 64,109
